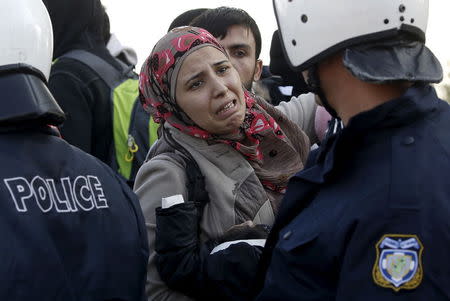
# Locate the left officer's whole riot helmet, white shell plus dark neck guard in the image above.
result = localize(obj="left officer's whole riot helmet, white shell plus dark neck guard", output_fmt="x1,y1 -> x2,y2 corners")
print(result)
0,0 -> 64,127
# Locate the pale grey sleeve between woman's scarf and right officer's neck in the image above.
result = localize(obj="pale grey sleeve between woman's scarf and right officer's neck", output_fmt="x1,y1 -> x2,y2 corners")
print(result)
276,93 -> 319,144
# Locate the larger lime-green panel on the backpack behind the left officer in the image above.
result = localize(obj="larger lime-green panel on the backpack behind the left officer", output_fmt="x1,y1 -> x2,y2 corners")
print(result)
112,79 -> 139,179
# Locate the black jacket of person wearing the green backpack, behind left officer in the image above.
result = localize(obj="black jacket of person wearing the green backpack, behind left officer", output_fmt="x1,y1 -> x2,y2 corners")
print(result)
43,0 -> 121,164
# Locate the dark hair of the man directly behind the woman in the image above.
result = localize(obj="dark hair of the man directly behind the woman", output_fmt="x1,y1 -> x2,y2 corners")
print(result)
189,6 -> 261,59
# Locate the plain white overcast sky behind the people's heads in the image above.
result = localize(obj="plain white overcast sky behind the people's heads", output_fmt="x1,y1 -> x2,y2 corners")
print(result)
101,0 -> 450,83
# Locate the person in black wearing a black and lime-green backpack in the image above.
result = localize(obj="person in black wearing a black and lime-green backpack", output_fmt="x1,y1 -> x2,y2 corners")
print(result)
44,0 -> 157,186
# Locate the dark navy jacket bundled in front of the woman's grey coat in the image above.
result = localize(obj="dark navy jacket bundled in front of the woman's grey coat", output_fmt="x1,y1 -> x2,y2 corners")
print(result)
155,202 -> 267,301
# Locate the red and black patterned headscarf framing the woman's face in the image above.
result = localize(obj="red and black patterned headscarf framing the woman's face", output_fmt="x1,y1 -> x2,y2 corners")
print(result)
139,27 -> 304,192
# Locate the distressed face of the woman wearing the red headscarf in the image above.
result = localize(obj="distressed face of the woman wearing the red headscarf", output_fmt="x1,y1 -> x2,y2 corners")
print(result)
175,46 -> 245,135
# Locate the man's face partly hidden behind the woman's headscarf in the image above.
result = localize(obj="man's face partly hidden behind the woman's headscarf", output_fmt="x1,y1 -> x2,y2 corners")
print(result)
219,25 -> 262,90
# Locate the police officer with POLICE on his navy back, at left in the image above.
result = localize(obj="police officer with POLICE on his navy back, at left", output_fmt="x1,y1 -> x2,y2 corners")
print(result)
0,0 -> 148,301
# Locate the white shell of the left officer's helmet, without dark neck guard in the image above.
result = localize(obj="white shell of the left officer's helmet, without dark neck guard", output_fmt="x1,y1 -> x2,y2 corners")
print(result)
0,0 -> 53,81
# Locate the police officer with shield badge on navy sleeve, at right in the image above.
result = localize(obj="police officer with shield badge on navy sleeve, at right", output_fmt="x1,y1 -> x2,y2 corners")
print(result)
257,0 -> 450,301
